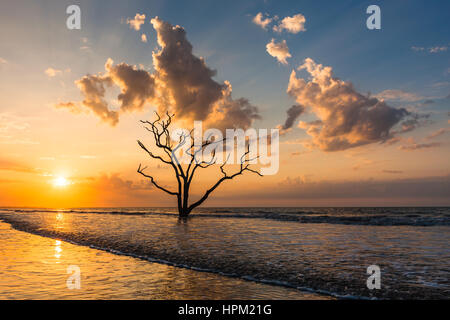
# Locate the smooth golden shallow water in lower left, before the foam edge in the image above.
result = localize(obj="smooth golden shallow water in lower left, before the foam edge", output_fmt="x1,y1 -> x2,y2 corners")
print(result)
0,222 -> 327,299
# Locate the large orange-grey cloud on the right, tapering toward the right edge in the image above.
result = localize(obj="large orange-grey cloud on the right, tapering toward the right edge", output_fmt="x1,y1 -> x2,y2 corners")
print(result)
287,58 -> 410,151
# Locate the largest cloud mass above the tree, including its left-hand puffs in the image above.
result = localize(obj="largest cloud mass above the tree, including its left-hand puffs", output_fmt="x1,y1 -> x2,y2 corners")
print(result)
57,17 -> 260,129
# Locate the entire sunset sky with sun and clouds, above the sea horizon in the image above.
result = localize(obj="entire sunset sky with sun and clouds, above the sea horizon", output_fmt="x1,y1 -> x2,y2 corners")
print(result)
0,0 -> 450,208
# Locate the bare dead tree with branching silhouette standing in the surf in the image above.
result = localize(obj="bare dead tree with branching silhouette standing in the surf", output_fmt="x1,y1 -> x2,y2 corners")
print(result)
137,113 -> 262,217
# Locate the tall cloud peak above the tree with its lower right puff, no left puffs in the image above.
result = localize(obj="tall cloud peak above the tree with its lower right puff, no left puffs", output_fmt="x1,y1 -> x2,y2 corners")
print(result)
151,17 -> 259,128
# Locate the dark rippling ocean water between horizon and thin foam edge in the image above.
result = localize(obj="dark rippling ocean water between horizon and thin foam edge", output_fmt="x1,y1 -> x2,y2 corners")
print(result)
0,208 -> 450,299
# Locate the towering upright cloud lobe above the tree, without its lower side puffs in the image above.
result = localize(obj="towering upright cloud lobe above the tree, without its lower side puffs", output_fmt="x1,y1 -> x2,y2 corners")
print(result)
151,17 -> 227,120
